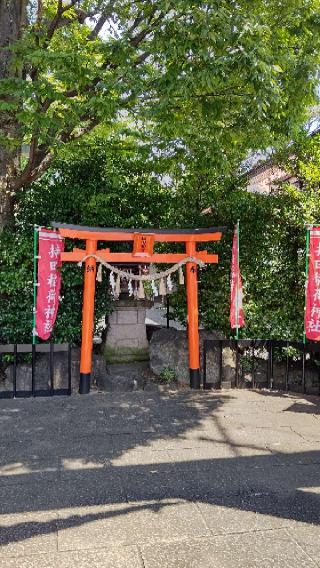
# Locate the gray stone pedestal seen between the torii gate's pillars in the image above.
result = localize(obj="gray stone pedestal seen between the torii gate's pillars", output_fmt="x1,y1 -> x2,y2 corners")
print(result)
105,299 -> 151,363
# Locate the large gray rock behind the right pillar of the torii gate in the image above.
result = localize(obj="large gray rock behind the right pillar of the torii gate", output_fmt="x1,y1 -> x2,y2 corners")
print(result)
150,329 -> 226,387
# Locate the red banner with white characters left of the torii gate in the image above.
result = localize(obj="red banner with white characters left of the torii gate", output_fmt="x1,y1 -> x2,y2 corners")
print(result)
35,229 -> 64,340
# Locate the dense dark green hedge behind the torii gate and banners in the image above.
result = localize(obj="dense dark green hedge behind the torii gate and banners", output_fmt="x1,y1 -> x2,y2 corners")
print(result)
0,133 -> 320,342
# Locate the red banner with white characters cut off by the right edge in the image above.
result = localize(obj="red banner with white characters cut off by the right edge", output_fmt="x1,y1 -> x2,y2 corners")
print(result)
305,227 -> 320,341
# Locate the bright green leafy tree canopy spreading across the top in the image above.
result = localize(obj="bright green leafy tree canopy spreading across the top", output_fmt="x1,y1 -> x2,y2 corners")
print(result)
0,0 -> 319,229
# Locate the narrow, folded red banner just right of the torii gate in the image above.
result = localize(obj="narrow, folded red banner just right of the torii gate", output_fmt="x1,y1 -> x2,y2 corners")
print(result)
230,224 -> 245,329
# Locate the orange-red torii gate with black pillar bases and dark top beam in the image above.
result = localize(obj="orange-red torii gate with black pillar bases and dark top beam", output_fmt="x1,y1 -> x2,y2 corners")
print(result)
53,223 -> 224,394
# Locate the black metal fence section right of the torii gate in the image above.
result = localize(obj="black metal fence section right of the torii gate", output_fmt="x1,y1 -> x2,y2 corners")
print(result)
203,339 -> 320,394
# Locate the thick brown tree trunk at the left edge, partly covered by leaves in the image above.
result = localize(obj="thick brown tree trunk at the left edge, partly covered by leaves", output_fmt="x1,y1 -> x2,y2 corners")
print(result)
0,0 -> 26,232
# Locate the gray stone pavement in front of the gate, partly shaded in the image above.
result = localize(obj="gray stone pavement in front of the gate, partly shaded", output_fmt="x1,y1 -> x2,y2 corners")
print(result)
0,391 -> 320,568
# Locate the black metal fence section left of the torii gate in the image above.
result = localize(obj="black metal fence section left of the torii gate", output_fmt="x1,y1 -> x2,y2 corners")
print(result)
0,343 -> 71,398
